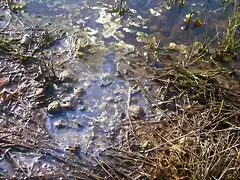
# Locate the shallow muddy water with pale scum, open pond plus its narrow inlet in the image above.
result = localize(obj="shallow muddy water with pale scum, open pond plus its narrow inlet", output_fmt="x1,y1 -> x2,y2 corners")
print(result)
0,0 -> 231,174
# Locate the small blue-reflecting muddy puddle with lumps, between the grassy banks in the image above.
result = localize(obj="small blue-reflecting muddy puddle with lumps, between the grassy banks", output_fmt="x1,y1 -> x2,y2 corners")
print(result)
47,54 -> 148,153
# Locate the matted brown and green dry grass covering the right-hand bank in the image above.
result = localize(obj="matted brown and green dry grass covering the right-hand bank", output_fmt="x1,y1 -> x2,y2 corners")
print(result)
97,4 -> 240,180
